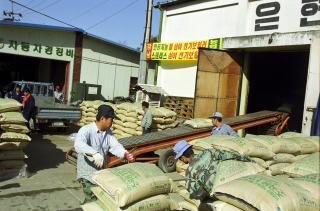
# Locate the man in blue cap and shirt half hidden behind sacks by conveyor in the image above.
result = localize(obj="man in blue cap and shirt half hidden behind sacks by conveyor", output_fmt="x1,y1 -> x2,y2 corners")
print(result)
209,112 -> 239,137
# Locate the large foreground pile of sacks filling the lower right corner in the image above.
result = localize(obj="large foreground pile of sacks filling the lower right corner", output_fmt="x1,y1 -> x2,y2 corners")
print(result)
177,132 -> 320,211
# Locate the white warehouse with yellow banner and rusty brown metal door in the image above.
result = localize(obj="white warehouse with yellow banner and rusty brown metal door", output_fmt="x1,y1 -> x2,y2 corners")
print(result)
147,0 -> 320,134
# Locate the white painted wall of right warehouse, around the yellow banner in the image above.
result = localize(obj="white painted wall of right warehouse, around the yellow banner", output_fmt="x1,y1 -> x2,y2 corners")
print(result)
157,0 -> 320,97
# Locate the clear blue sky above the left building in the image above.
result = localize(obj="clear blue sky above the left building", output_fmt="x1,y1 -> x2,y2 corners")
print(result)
0,0 -> 164,48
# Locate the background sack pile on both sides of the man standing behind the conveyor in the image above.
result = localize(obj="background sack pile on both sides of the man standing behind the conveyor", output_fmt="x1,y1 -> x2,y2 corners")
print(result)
112,103 -> 178,138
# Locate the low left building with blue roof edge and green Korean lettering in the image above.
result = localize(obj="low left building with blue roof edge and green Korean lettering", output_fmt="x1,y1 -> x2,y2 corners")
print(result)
0,21 -> 154,100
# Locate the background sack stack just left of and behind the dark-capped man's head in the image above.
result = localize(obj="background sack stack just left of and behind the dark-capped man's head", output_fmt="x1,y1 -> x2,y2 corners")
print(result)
78,100 -> 115,127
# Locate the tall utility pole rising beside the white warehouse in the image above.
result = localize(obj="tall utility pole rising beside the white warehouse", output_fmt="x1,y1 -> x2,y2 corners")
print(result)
138,0 -> 153,84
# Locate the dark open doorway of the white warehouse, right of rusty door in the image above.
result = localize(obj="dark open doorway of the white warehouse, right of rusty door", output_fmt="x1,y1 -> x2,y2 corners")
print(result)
247,49 -> 309,132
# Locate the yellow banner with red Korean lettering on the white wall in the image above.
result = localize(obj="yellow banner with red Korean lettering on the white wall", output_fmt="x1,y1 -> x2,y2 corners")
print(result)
146,38 -> 222,61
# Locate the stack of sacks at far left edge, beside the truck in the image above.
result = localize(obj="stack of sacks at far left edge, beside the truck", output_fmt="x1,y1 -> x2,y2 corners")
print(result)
0,98 -> 31,180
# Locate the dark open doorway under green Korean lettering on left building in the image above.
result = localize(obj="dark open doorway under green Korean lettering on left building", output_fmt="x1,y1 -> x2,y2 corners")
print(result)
0,53 -> 69,96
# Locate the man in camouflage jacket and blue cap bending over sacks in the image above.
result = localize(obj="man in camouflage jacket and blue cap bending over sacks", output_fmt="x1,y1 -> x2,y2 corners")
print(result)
173,140 -> 251,201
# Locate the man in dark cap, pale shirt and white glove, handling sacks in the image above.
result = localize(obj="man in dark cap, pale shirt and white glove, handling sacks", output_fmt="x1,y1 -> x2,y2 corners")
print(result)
74,105 -> 133,203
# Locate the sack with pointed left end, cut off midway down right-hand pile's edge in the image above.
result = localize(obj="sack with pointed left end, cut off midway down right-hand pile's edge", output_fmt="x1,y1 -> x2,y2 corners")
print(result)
283,152 -> 320,177
